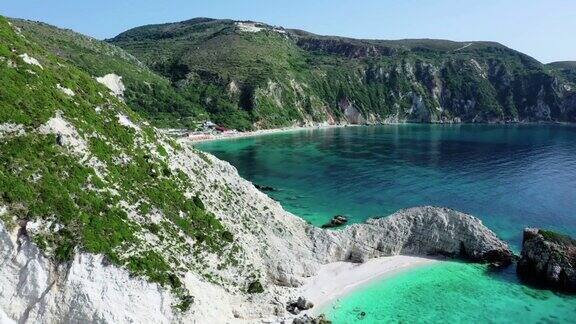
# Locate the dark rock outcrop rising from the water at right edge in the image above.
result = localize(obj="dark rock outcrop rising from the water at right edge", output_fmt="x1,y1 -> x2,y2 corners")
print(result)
517,228 -> 576,292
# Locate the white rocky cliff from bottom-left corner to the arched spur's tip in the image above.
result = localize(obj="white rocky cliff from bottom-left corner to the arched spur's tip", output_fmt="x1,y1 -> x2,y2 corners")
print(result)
0,199 -> 511,323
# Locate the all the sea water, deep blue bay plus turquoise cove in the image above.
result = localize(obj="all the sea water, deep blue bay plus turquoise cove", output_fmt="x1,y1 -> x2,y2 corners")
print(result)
199,125 -> 576,323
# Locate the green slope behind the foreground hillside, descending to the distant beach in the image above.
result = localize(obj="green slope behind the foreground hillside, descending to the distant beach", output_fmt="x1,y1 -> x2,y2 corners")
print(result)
11,19 -> 205,127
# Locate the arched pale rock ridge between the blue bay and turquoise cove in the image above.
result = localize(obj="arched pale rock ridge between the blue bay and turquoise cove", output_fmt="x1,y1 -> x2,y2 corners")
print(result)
312,207 -> 513,264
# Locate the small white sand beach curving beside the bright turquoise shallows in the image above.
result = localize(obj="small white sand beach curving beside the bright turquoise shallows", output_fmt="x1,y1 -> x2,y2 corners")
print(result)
300,255 -> 441,316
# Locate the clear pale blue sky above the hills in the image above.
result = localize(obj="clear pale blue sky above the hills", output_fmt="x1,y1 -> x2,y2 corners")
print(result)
0,0 -> 576,63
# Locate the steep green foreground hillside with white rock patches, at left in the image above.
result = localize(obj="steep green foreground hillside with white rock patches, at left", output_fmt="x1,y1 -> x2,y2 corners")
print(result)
0,17 -> 243,309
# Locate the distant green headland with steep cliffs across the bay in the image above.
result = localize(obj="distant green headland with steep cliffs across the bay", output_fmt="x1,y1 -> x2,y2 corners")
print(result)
109,18 -> 576,128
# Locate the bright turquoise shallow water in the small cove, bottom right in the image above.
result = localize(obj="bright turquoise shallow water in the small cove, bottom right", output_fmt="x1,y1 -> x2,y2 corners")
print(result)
325,262 -> 576,323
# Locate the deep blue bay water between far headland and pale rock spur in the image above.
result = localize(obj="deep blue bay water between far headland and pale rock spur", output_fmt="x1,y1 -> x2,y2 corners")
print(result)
198,125 -> 576,249
